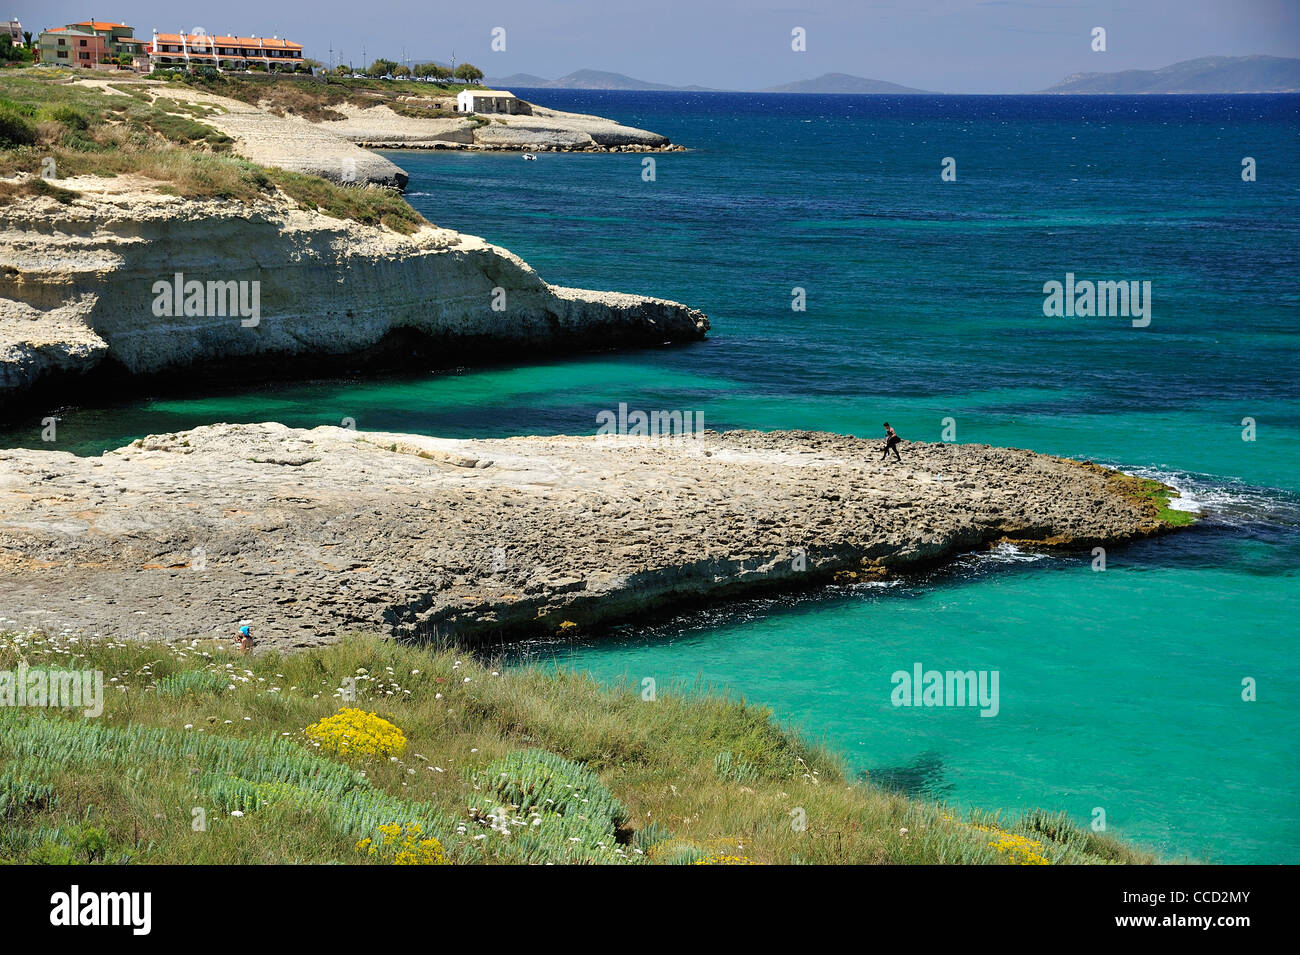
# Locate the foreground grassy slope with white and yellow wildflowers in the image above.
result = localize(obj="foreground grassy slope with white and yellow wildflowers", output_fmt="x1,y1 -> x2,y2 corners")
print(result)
0,634 -> 1152,864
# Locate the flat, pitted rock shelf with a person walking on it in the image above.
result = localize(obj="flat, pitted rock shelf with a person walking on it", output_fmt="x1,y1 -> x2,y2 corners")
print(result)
0,424 -> 1160,647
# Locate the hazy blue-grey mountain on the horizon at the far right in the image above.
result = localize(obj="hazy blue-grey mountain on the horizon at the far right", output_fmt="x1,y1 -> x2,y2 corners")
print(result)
1044,56 -> 1300,94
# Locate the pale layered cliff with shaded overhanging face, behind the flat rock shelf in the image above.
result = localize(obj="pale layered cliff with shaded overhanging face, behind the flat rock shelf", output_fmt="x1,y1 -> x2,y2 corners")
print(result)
0,183 -> 709,402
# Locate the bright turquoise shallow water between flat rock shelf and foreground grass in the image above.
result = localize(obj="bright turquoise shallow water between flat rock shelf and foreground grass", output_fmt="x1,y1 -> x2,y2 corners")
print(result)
512,530 -> 1300,861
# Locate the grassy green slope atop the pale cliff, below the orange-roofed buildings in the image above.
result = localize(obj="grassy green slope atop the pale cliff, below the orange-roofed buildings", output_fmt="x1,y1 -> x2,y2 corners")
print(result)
0,68 -> 425,234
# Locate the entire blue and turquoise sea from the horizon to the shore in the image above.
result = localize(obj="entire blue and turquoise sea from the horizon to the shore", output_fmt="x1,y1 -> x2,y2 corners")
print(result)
0,90 -> 1300,863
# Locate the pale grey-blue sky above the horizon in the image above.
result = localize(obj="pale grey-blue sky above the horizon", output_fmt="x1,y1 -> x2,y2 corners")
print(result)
8,0 -> 1300,92
